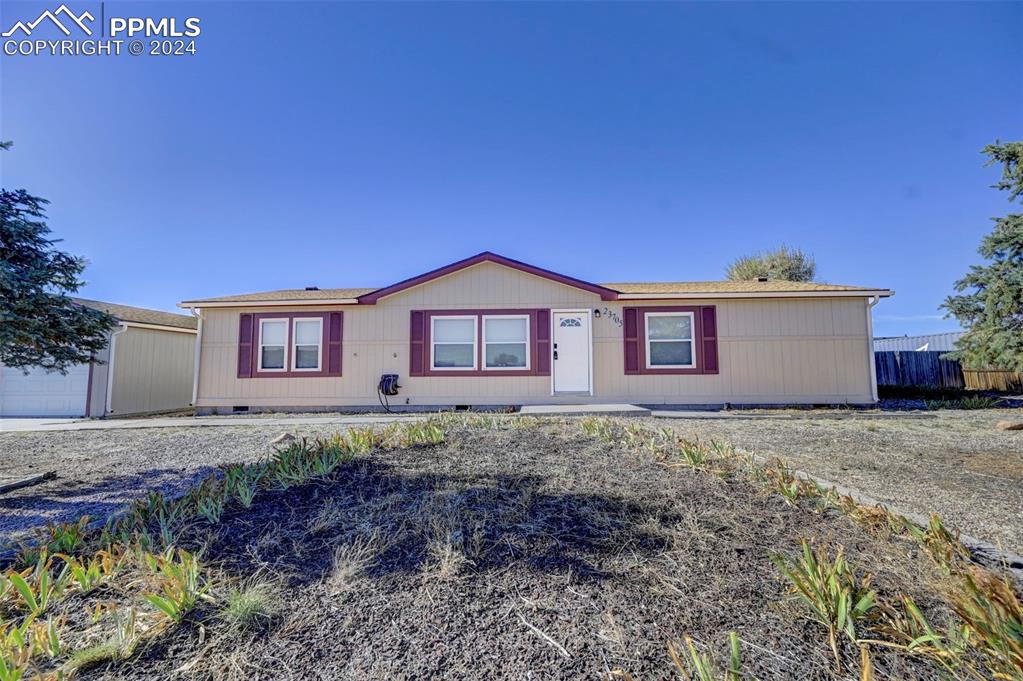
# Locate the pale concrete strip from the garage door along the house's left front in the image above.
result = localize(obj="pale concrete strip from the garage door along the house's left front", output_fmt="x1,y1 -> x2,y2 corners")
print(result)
0,414 -> 424,434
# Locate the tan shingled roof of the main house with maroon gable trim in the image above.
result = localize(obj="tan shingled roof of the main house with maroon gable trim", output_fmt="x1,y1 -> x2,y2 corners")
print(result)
180,252 -> 891,308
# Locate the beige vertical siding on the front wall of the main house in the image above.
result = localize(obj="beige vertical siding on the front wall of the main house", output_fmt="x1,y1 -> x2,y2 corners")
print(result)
196,263 -> 873,408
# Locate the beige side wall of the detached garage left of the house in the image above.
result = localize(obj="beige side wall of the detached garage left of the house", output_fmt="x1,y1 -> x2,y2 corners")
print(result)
107,326 -> 195,415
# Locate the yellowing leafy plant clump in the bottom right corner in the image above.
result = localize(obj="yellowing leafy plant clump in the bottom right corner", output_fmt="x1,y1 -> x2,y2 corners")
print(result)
950,566 -> 1023,681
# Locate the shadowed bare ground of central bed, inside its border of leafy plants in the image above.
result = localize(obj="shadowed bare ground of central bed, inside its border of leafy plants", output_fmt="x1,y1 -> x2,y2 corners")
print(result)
68,422 -> 948,680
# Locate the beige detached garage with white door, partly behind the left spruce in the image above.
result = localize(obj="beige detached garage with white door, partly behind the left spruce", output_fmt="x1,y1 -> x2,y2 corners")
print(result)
0,298 -> 197,417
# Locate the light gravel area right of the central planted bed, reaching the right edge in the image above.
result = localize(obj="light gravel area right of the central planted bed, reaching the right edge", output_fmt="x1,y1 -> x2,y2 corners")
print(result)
646,409 -> 1023,555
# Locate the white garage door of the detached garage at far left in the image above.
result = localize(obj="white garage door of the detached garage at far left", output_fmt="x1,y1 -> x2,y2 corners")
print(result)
0,364 -> 89,416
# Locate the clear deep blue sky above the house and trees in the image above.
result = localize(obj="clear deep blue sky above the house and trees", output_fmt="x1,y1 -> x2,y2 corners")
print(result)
0,0 -> 1023,334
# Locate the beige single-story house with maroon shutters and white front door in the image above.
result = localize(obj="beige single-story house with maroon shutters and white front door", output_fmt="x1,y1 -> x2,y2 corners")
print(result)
179,253 -> 891,413
